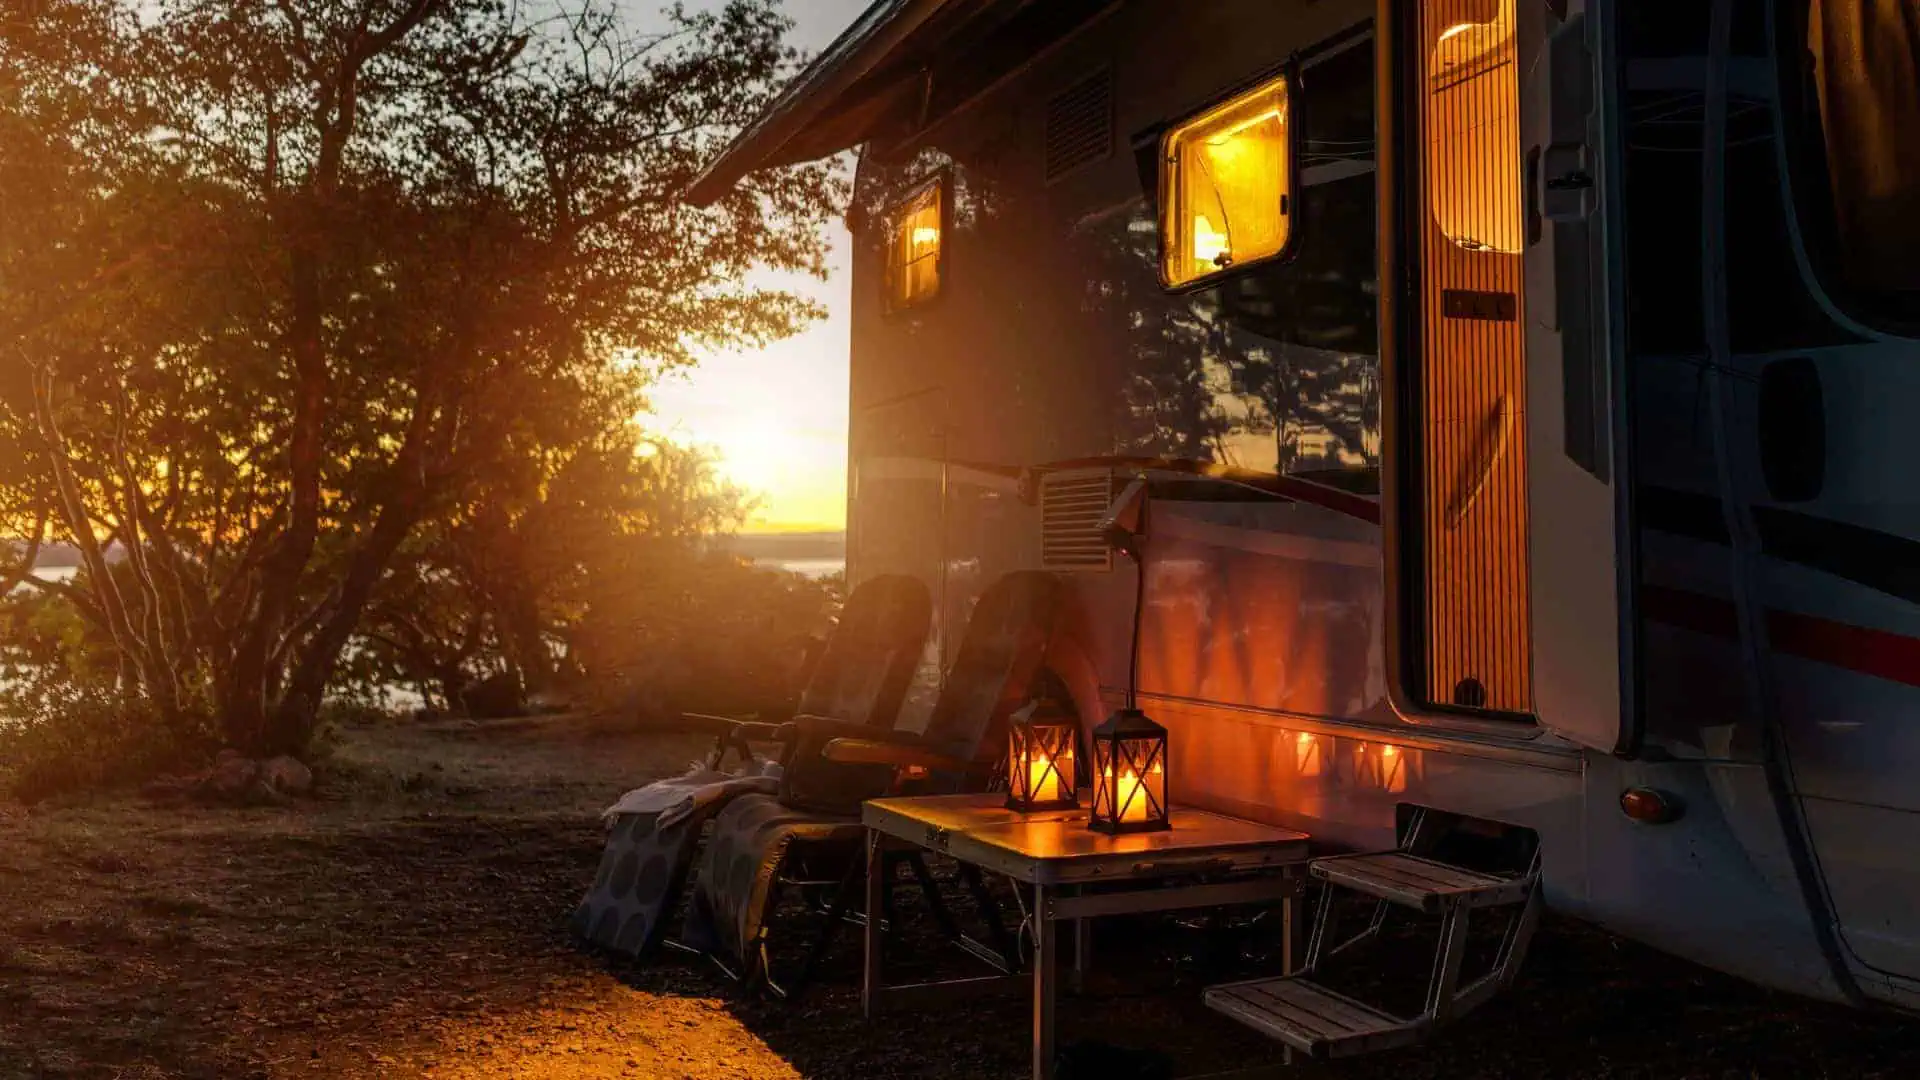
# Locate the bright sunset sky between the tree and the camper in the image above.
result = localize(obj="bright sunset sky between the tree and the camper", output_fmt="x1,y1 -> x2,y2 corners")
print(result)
645,0 -> 868,532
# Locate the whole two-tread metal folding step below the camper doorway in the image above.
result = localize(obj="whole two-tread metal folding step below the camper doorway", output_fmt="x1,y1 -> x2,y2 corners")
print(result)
1204,813 -> 1540,1059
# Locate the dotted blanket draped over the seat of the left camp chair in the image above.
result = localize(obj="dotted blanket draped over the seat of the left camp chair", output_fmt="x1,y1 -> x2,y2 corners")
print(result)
572,763 -> 780,957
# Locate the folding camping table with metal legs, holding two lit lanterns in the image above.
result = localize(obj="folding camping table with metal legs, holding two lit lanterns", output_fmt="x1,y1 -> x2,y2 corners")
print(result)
860,794 -> 1308,1080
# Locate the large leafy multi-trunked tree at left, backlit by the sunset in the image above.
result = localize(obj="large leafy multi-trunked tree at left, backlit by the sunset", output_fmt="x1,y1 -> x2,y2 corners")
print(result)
0,0 -> 839,753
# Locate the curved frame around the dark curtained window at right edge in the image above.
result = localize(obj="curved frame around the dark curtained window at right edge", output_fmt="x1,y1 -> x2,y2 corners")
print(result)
1768,0 -> 1920,338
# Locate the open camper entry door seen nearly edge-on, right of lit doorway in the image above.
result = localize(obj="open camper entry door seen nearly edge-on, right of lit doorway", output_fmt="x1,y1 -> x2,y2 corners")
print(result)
1509,0 -> 1636,751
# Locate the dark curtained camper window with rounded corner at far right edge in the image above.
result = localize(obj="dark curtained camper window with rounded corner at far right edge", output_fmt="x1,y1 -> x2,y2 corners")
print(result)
1797,0 -> 1920,329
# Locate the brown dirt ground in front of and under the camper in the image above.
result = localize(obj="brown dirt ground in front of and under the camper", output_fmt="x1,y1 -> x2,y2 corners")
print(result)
0,717 -> 1920,1080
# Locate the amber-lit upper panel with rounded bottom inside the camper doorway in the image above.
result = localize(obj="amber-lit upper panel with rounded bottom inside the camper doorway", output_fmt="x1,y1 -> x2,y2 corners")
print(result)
1427,0 -> 1523,256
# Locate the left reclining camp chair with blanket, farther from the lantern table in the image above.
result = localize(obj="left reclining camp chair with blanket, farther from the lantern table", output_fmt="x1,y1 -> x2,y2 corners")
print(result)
572,575 -> 931,957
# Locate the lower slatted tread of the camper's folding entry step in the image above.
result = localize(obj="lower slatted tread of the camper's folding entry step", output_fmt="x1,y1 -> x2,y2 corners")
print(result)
1204,976 -> 1428,1059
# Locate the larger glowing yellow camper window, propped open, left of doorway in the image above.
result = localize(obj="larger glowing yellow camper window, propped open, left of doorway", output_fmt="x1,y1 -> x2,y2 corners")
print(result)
1160,75 -> 1292,288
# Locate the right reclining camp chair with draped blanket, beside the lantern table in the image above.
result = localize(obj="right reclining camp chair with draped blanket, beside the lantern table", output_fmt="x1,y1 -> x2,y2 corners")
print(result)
687,571 -> 1062,997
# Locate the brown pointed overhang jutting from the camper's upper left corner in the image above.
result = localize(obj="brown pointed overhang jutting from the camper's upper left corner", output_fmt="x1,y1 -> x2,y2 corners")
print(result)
684,0 -> 960,206
